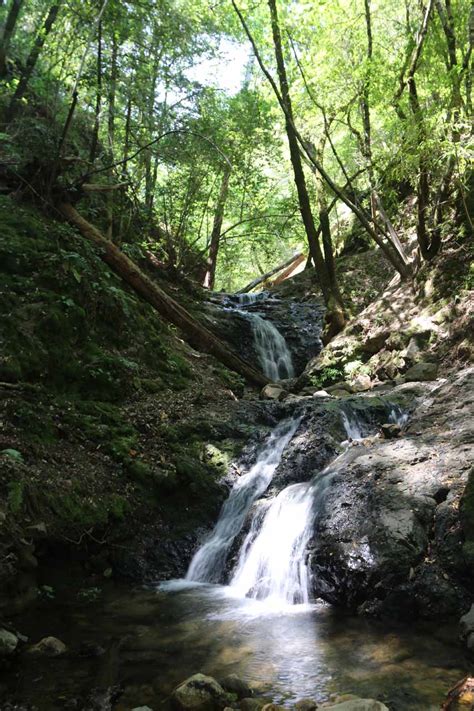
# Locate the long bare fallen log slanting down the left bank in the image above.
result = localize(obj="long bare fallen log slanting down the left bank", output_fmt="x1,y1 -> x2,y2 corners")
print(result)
57,203 -> 269,385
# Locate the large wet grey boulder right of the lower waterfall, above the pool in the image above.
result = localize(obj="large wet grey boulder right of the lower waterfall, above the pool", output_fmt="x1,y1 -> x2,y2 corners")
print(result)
309,369 -> 474,619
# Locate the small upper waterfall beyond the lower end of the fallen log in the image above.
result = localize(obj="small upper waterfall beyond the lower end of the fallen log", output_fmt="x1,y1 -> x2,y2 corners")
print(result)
252,314 -> 295,381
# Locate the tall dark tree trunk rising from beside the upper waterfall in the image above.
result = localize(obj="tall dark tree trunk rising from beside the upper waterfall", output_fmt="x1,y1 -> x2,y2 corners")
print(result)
268,0 -> 345,330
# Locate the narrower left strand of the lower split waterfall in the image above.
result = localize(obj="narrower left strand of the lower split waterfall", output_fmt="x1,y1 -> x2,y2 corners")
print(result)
186,418 -> 301,582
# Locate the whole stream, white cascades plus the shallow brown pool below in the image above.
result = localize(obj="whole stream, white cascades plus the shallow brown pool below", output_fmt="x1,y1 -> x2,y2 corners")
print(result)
0,297 -> 465,711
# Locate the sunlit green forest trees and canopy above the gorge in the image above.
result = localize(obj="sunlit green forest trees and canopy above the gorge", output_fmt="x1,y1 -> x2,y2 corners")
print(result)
0,0 -> 474,300
